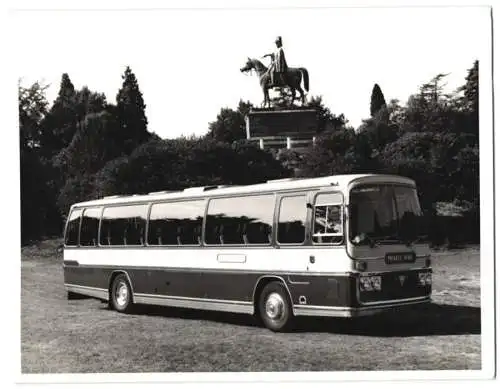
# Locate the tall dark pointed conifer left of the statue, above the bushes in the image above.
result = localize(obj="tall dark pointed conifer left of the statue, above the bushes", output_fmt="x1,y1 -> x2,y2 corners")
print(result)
116,66 -> 150,154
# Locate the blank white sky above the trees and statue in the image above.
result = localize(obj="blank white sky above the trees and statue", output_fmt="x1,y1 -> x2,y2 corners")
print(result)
11,7 -> 490,138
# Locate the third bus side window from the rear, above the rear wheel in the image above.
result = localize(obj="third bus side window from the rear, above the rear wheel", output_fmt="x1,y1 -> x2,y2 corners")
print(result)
100,204 -> 147,246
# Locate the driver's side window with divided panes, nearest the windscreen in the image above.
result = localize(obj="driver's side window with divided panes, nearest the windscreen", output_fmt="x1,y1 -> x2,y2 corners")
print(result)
313,193 -> 343,244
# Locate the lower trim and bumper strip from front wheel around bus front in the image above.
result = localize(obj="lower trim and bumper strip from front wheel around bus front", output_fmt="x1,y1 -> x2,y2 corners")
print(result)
294,297 -> 431,317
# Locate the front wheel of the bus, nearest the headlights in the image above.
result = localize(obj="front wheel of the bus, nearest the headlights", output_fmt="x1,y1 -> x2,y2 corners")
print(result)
259,281 -> 293,332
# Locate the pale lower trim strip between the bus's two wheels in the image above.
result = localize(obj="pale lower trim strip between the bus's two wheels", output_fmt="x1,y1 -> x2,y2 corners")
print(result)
134,293 -> 254,315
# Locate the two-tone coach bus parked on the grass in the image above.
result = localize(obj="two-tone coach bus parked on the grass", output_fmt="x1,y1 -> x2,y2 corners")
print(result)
63,174 -> 432,331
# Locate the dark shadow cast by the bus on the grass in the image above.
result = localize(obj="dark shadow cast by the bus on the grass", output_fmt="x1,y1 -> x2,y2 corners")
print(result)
102,304 -> 481,337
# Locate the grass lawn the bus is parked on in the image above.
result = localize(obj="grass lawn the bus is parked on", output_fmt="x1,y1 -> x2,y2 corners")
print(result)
21,241 -> 481,373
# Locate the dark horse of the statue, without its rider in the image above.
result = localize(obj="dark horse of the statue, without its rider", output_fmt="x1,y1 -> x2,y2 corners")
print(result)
240,58 -> 309,107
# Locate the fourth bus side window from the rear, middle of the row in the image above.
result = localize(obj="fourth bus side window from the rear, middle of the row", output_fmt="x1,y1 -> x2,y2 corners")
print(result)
148,200 -> 205,246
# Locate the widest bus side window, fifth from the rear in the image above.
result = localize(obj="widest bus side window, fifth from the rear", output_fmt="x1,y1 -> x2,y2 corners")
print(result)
205,194 -> 275,245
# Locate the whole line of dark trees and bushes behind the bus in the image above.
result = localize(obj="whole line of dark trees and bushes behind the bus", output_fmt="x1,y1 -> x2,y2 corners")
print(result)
19,61 -> 479,242
